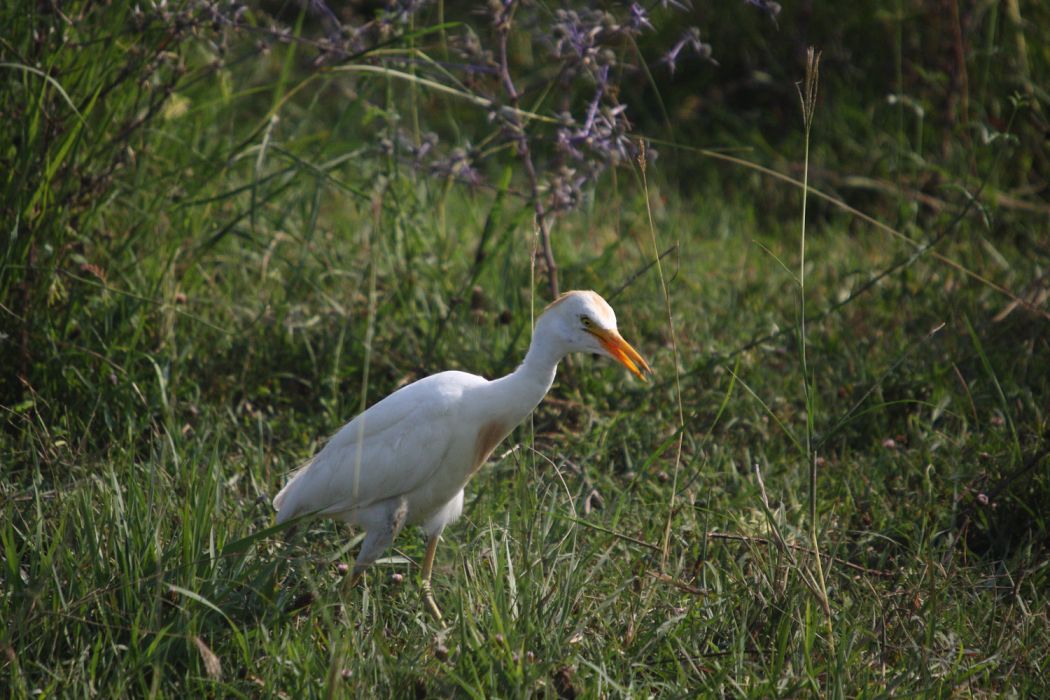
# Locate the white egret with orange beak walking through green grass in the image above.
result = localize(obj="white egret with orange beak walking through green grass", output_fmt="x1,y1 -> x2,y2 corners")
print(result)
273,291 -> 652,620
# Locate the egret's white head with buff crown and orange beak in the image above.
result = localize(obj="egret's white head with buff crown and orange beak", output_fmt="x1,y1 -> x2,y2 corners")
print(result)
537,291 -> 652,381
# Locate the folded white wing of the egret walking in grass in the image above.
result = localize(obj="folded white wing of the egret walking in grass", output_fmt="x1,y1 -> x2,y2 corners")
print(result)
274,372 -> 485,523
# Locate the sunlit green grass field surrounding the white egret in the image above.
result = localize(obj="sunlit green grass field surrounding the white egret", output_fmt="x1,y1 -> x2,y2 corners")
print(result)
0,3 -> 1050,698
